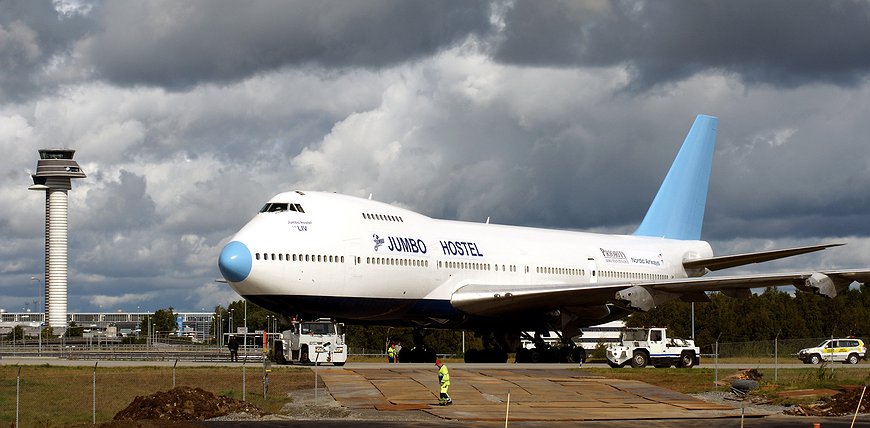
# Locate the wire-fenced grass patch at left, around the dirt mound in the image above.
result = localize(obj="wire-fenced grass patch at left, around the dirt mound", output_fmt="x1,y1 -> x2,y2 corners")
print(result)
0,361 -> 312,426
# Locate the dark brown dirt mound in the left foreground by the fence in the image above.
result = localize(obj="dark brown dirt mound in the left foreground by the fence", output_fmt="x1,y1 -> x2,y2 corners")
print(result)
114,386 -> 267,421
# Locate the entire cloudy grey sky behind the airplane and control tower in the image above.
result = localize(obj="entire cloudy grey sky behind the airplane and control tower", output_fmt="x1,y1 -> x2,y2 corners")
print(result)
0,0 -> 870,311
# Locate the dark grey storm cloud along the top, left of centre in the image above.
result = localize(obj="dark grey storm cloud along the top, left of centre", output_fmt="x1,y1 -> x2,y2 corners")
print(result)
81,0 -> 490,88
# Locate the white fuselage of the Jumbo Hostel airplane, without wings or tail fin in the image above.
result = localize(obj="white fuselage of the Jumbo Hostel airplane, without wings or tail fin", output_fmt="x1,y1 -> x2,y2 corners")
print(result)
220,192 -> 712,325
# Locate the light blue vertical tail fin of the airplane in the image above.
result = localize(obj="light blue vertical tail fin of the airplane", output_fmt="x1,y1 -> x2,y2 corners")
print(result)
634,115 -> 719,240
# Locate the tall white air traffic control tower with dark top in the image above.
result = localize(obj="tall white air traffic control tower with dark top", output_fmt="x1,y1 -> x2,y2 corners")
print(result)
29,149 -> 85,333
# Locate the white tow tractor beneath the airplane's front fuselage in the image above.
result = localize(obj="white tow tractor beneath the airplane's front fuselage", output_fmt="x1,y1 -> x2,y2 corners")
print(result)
274,318 -> 347,366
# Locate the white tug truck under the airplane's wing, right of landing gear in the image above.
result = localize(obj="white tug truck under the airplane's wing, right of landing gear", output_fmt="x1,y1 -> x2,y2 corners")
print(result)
607,328 -> 701,368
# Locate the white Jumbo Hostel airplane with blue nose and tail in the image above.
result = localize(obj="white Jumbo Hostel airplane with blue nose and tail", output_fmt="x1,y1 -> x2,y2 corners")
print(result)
218,115 -> 870,361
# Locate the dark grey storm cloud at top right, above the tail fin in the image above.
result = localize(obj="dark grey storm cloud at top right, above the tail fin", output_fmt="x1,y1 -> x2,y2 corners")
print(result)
495,0 -> 870,89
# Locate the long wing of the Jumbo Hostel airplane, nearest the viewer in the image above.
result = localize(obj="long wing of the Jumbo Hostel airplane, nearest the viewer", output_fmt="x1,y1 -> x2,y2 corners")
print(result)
450,270 -> 870,316
